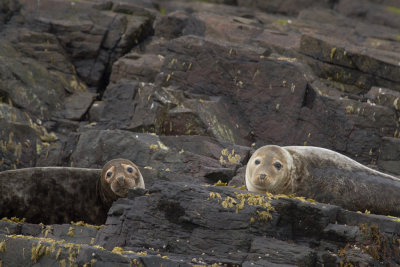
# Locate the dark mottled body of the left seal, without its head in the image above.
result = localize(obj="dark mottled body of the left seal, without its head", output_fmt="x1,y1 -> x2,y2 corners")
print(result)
0,167 -> 107,224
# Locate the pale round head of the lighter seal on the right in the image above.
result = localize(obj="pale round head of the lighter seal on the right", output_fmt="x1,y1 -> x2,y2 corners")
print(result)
246,145 -> 293,193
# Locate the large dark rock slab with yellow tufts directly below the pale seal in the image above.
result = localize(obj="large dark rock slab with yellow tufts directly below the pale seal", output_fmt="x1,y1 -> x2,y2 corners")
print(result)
95,181 -> 400,266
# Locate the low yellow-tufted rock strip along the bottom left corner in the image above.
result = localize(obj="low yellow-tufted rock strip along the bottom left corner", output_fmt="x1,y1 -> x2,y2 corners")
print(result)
0,231 -> 189,267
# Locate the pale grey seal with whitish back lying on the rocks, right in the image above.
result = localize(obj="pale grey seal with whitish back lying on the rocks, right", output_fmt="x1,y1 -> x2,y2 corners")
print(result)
245,145 -> 400,216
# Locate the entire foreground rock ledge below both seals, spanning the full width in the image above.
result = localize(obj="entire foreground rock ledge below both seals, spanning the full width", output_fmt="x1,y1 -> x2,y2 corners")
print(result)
0,181 -> 400,266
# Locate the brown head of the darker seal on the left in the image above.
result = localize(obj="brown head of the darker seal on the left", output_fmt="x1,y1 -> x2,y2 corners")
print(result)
98,159 -> 145,206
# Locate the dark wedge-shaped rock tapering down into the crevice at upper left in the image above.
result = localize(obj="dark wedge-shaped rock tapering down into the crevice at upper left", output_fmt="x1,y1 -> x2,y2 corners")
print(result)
21,0 -> 154,86
